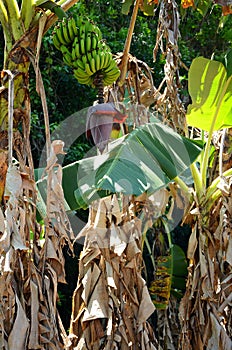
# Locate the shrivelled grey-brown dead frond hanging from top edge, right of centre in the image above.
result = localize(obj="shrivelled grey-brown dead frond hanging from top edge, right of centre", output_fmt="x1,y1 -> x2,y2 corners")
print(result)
154,0 -> 186,133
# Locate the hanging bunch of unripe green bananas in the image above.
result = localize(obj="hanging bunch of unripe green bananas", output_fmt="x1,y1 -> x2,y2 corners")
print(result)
53,17 -> 120,86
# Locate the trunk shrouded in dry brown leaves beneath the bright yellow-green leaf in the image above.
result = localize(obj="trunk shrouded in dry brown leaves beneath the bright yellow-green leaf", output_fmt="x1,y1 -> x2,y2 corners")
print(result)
179,130 -> 232,350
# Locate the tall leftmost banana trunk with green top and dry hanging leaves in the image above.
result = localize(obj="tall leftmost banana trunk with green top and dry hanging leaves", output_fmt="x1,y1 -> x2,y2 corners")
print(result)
0,0 -> 78,350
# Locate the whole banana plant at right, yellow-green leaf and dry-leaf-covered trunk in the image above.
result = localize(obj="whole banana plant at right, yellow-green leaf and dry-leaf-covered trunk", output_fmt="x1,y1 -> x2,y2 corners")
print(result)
180,55 -> 232,350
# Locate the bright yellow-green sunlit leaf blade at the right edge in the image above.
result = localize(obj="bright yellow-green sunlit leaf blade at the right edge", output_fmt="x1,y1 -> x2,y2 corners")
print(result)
187,57 -> 232,131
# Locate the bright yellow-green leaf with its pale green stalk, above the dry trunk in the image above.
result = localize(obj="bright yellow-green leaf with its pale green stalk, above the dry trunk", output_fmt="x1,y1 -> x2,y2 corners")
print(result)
187,57 -> 232,202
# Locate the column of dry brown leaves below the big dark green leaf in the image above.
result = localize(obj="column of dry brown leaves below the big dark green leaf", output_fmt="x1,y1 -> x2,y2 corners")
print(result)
70,195 -> 158,350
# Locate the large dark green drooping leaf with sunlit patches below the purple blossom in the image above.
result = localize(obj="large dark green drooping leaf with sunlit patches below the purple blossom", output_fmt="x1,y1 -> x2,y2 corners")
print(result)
73,122 -> 201,208
